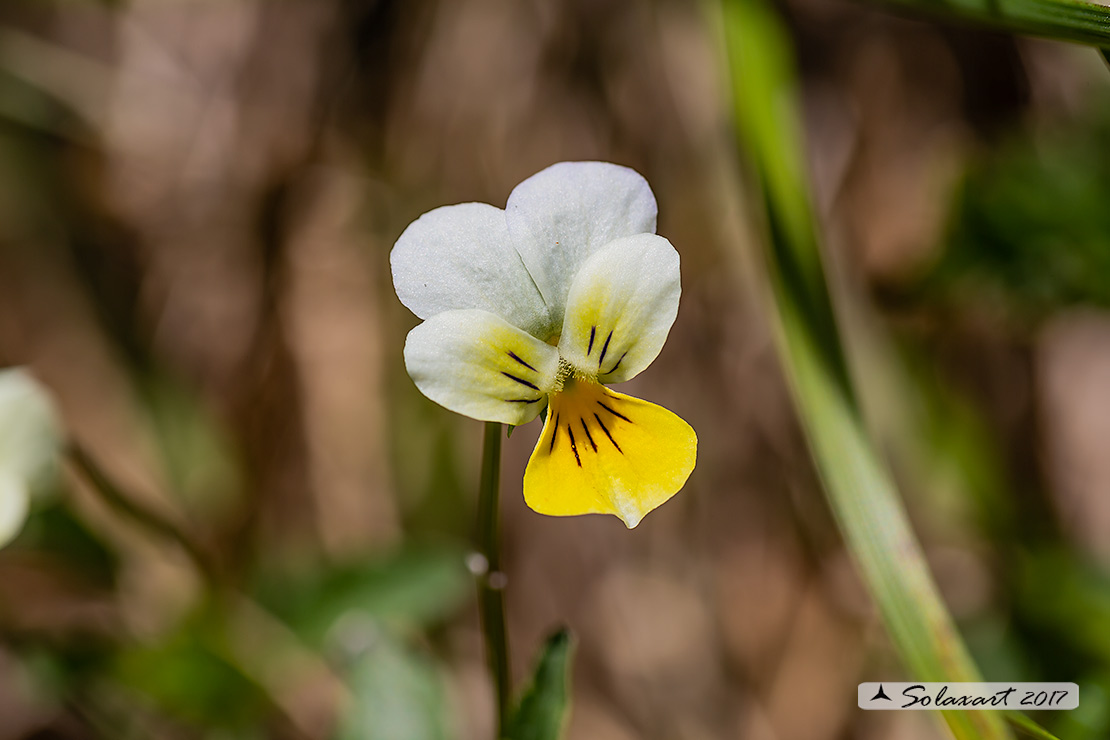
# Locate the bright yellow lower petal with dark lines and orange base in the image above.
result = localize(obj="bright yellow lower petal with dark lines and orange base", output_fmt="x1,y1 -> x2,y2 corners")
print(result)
524,379 -> 697,528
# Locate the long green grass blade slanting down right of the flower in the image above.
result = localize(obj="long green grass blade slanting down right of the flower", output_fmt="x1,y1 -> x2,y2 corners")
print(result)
720,0 -> 1012,740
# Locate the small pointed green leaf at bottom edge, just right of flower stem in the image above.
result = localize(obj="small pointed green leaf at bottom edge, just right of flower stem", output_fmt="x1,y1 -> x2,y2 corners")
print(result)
503,629 -> 573,740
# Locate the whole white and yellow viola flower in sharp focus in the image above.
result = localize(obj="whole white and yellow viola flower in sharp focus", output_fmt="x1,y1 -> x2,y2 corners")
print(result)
390,162 -> 697,528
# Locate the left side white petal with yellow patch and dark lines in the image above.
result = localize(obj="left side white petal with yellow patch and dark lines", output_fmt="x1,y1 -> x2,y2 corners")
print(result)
405,310 -> 558,424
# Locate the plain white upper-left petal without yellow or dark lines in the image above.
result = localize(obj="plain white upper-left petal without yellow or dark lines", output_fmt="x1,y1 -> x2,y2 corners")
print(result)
390,203 -> 551,338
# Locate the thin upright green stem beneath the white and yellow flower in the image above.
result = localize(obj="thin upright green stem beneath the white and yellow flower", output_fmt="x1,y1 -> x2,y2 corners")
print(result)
477,422 -> 512,738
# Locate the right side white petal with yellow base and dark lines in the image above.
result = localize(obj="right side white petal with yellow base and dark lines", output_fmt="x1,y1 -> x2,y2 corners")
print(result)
558,234 -> 682,383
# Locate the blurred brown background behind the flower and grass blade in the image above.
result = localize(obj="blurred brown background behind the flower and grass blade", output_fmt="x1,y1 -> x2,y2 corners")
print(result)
0,0 -> 1110,740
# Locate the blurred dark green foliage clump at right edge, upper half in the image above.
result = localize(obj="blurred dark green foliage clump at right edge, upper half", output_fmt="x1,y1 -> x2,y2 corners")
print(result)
922,110 -> 1110,318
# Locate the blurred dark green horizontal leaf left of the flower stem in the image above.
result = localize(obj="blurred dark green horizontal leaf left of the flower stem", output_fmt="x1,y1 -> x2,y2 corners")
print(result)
256,545 -> 472,646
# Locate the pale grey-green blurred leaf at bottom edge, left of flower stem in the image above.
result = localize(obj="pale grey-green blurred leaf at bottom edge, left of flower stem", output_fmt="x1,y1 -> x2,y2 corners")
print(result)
336,620 -> 450,740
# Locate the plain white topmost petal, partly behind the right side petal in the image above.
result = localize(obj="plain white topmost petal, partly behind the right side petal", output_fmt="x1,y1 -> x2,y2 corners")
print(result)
505,162 -> 657,331
